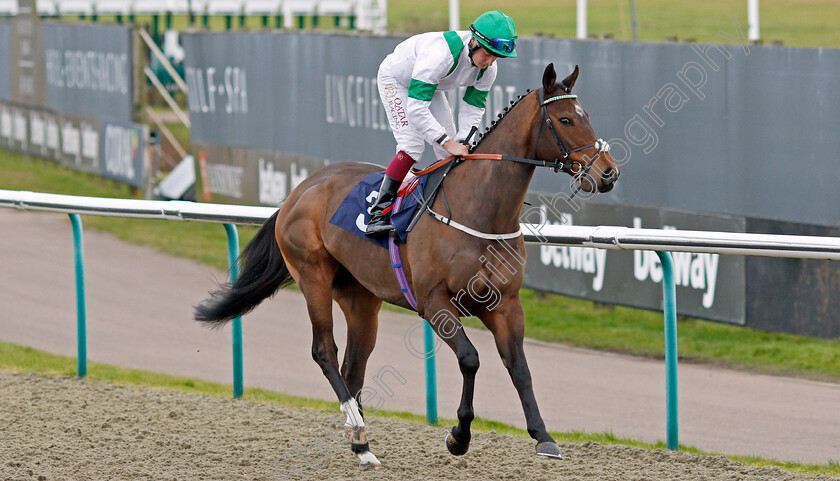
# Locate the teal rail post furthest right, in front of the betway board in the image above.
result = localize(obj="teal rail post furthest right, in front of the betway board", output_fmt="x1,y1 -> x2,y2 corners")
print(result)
656,251 -> 680,451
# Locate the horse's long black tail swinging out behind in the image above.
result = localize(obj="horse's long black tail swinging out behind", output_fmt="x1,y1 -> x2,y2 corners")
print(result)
195,211 -> 294,327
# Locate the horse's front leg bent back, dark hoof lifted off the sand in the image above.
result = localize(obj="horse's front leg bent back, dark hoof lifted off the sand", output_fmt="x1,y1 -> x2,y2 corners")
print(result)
421,289 -> 479,456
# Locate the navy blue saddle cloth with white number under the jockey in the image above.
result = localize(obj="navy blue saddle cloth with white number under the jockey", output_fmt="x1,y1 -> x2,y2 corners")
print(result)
330,171 -> 429,249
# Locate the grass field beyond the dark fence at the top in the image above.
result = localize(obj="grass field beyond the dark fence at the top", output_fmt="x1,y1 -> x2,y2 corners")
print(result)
57,0 -> 840,48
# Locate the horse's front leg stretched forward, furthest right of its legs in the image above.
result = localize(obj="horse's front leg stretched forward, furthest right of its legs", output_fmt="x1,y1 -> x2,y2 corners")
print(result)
478,294 -> 562,458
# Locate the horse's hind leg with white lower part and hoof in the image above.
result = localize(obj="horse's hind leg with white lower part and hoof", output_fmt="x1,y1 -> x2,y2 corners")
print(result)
298,255 -> 380,468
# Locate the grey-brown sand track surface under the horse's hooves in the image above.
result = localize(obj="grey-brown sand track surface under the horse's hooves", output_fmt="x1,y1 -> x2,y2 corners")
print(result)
0,372 -> 836,481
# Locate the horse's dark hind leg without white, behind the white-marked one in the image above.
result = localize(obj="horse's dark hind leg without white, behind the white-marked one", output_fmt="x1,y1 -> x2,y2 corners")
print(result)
333,271 -> 382,410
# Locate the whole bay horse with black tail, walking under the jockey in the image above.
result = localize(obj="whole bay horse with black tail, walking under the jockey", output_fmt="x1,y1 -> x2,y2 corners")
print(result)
195,64 -> 619,467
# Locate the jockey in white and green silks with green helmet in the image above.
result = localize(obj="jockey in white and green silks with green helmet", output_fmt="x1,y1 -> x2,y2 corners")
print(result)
365,10 -> 516,237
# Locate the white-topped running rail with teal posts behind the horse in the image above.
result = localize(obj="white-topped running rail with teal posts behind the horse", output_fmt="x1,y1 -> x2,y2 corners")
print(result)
0,190 -> 840,450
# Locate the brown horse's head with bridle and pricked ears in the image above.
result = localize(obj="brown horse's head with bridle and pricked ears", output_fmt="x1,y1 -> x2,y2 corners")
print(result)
532,64 -> 619,192
